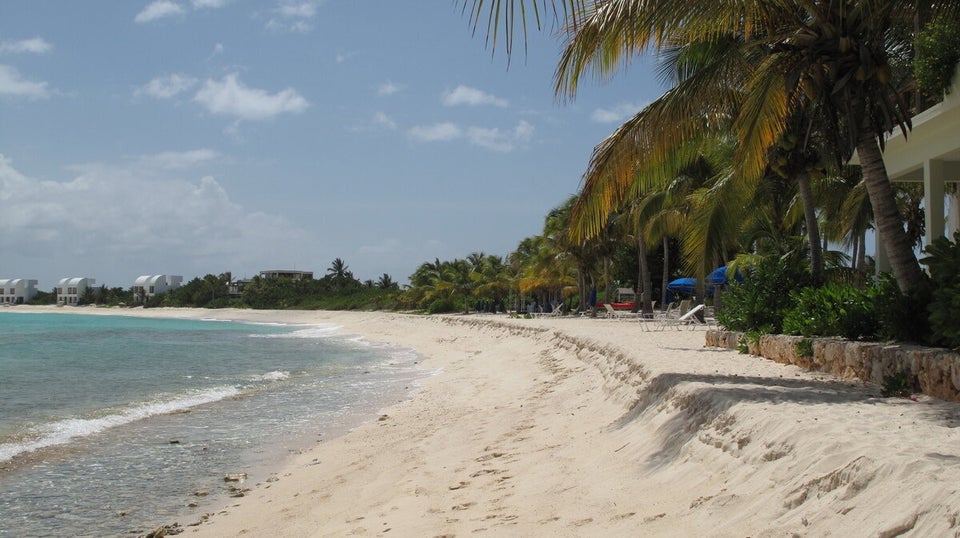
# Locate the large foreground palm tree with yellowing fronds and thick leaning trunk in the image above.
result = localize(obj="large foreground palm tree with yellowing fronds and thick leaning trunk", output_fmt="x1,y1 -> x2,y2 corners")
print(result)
462,0 -> 957,292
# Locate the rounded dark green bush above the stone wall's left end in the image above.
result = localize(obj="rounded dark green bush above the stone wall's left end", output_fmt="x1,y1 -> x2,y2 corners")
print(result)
717,257 -> 812,333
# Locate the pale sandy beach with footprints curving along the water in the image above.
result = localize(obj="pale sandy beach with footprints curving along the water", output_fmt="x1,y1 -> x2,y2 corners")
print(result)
13,308 -> 960,537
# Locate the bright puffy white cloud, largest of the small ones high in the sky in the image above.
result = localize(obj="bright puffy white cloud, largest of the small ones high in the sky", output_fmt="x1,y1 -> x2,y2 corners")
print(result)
193,73 -> 310,120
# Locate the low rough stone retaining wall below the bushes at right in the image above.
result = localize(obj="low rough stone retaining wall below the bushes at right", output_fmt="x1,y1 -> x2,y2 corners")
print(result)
706,330 -> 960,402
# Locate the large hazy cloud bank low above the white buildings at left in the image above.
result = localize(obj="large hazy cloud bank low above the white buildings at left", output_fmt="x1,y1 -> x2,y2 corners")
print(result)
0,153 -> 308,284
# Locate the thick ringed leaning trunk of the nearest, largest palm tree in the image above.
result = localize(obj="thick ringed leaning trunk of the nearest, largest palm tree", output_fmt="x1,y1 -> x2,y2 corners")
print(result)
857,134 -> 923,294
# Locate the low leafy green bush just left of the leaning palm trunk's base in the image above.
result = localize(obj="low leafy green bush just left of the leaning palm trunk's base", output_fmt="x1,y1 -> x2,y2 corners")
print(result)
783,283 -> 880,340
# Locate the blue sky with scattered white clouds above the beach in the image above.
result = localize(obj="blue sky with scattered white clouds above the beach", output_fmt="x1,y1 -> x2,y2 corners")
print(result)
0,0 -> 662,290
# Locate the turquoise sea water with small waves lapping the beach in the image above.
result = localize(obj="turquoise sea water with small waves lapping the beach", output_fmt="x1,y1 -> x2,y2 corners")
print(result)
0,312 -> 423,538
